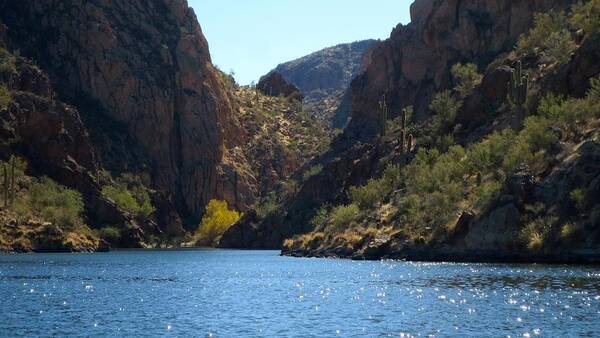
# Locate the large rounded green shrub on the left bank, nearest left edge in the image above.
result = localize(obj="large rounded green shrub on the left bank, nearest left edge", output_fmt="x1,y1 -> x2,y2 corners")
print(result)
28,177 -> 84,228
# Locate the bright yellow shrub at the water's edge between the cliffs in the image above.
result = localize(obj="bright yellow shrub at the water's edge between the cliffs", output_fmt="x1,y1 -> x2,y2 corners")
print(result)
196,200 -> 240,246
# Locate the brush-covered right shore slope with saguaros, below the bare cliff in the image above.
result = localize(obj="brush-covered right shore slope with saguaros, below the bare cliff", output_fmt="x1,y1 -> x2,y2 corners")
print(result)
278,1 -> 600,262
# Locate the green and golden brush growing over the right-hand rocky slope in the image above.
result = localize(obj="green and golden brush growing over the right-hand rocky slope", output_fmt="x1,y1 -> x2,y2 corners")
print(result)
283,1 -> 600,259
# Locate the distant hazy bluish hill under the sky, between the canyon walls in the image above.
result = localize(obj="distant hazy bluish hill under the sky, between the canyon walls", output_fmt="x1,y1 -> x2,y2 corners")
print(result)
275,40 -> 378,128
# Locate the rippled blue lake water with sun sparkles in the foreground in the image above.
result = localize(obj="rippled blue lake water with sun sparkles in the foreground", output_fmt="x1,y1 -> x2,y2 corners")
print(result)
0,251 -> 600,337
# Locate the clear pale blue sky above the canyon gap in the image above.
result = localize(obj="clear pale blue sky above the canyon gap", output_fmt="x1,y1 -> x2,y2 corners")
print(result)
188,0 -> 412,84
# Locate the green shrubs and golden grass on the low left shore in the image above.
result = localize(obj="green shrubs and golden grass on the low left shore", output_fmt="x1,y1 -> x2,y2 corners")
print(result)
0,157 -> 100,252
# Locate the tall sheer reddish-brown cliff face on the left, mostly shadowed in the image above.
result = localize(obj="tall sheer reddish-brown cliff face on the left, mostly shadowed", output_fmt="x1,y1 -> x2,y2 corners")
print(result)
0,0 -> 242,222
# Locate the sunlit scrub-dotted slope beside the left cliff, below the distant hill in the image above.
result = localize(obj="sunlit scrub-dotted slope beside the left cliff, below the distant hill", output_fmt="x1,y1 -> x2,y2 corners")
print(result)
234,87 -> 330,201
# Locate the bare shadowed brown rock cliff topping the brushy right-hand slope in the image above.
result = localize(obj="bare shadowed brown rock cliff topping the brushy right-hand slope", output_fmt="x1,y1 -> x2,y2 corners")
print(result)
346,0 -> 573,140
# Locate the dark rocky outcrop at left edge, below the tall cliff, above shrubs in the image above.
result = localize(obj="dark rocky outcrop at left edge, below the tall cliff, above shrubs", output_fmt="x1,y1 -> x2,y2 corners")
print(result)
0,40 -> 143,248
